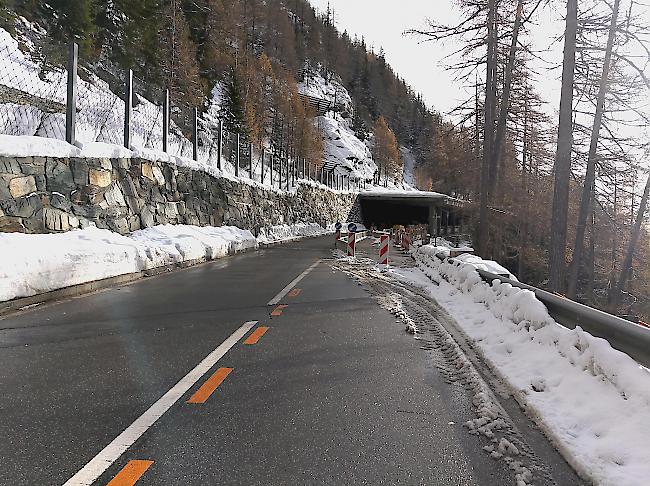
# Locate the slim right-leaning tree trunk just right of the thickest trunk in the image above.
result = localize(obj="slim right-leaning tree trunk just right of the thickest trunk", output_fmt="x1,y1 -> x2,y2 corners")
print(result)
567,0 -> 621,299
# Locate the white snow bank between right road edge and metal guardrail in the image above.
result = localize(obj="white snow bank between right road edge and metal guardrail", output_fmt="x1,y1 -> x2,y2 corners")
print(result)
395,246 -> 650,486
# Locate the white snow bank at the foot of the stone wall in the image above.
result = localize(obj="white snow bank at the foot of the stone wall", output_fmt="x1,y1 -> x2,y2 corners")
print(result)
0,225 -> 257,301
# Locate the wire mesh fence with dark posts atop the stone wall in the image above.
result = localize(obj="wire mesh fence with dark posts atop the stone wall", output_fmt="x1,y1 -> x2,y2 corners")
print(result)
0,35 -> 362,190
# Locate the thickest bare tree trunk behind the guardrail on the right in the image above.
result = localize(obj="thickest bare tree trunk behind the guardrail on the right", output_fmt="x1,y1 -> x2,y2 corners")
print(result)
549,0 -> 578,291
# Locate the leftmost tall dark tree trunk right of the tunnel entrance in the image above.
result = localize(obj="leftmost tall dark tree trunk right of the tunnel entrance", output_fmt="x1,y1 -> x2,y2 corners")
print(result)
478,0 -> 497,258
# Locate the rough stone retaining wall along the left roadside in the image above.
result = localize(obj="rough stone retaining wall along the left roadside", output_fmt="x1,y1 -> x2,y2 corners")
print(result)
0,157 -> 360,234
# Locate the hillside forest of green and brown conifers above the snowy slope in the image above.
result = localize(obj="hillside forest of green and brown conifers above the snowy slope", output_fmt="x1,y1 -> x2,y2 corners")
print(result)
2,0 -> 469,185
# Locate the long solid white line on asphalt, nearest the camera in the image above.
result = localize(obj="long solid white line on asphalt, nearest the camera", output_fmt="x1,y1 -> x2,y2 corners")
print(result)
63,321 -> 257,486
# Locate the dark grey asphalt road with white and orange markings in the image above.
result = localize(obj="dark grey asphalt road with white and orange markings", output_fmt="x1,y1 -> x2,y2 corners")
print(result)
0,234 -> 576,486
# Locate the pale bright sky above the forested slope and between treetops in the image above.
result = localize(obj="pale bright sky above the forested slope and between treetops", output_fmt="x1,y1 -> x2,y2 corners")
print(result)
310,0 -> 563,119
